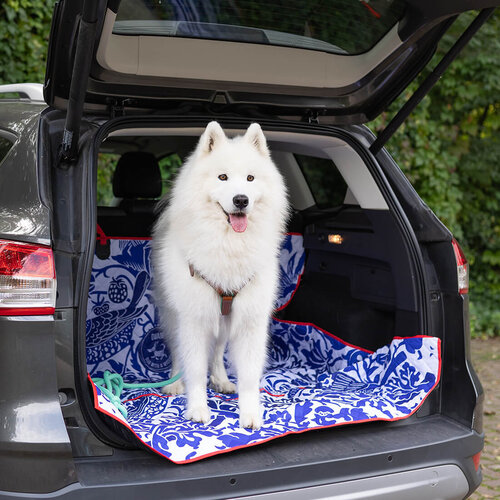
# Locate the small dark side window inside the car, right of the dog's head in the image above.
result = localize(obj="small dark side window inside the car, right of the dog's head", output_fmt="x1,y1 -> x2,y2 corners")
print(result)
295,154 -> 347,208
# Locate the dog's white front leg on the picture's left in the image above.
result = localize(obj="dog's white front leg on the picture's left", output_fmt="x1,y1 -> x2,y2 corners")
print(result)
178,319 -> 211,424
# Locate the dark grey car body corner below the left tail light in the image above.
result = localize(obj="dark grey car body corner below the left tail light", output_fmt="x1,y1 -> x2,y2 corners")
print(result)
0,315 -> 76,493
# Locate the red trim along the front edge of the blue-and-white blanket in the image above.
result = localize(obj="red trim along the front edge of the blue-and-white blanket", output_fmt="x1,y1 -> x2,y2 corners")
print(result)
88,334 -> 442,464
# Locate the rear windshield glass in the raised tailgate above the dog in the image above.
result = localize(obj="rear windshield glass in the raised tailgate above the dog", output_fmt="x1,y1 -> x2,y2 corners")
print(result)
113,0 -> 404,54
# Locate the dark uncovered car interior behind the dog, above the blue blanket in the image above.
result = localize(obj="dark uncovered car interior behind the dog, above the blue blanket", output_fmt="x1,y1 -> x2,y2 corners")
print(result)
96,129 -> 426,350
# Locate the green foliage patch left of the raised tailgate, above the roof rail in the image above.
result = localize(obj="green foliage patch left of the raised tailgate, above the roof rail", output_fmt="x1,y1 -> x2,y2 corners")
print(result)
0,0 -> 55,83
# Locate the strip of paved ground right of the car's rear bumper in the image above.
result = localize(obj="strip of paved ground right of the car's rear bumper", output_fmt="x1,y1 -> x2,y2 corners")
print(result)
470,337 -> 500,500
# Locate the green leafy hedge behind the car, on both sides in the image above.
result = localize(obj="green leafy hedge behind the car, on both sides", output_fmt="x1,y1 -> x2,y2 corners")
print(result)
0,0 -> 500,336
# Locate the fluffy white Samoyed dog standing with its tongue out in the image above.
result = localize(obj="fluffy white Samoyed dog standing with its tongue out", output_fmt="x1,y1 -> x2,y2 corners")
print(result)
153,122 -> 288,429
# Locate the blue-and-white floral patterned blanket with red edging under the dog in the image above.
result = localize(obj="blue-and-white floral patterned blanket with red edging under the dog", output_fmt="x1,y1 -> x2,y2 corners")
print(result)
87,234 -> 441,463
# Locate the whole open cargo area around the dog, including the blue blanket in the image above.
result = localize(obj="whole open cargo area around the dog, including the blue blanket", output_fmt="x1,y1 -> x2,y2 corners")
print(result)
79,125 -> 441,463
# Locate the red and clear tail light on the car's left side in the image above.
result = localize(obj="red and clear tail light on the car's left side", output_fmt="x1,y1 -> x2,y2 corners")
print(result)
0,240 -> 56,316
